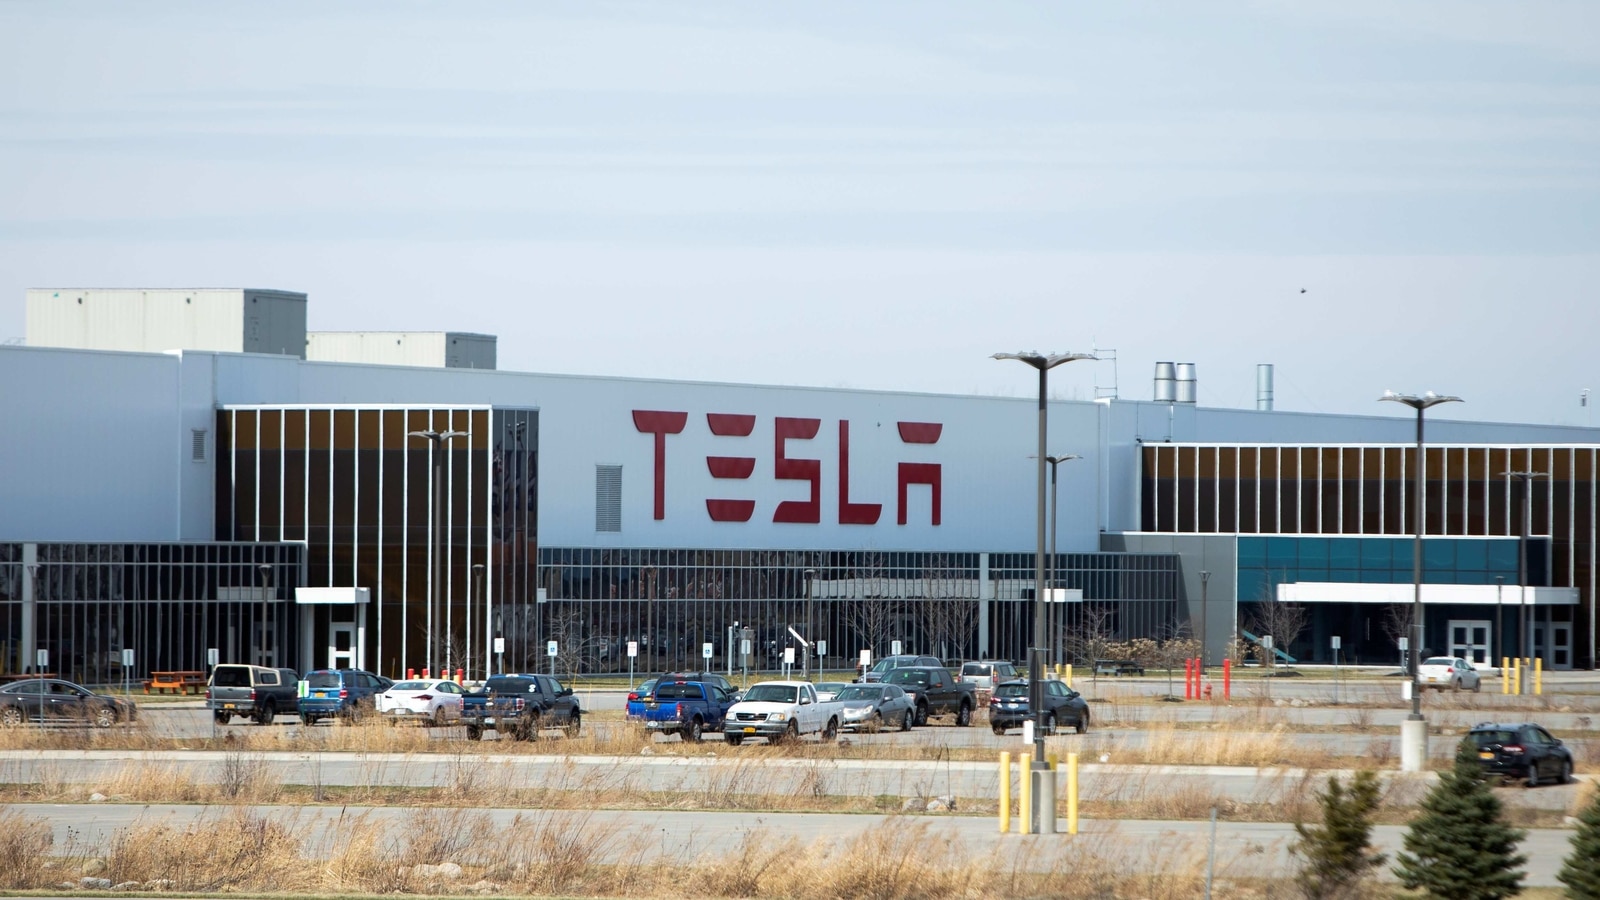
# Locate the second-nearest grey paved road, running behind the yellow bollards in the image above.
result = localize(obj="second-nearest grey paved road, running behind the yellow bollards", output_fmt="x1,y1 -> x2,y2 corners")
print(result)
0,749 -> 1578,812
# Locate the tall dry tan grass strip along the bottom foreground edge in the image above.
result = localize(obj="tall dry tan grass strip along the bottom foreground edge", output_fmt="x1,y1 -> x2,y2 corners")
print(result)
0,797 -> 1312,900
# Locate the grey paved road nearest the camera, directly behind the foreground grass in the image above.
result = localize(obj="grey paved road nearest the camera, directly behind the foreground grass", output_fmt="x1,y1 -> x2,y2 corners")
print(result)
3,804 -> 1571,887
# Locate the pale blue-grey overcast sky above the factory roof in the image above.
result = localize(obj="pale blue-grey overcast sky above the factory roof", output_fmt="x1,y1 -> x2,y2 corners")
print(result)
0,0 -> 1600,424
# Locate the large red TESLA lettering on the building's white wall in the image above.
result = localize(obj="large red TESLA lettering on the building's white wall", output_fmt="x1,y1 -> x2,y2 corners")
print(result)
634,410 -> 944,525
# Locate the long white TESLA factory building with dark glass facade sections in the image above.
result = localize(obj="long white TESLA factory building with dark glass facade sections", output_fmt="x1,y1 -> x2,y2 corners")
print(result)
0,288 -> 1600,681
